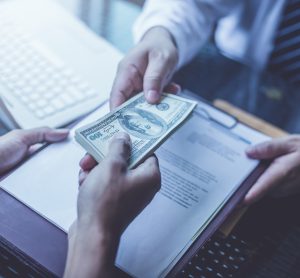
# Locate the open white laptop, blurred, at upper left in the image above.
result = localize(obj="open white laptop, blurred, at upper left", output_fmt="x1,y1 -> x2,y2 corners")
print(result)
0,0 -> 122,129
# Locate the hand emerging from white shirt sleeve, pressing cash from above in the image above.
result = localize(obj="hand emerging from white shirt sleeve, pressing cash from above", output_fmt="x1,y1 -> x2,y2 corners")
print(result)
110,27 -> 178,109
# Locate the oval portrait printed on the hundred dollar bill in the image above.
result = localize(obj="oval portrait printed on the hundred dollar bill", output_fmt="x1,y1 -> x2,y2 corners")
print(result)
119,108 -> 168,140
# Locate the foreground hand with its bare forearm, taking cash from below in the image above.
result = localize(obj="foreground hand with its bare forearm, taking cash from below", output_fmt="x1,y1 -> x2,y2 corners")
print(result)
66,133 -> 161,277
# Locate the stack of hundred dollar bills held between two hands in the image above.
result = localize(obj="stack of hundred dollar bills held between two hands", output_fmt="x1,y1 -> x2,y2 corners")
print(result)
75,93 -> 196,168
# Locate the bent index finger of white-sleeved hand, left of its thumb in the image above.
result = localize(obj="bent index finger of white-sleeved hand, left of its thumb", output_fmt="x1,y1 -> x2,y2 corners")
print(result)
110,62 -> 143,109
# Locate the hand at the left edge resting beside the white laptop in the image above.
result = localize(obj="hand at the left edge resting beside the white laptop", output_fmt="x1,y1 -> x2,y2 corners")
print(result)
0,127 -> 69,174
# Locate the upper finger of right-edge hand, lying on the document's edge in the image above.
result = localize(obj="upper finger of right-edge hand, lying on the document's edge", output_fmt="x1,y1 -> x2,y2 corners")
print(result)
246,138 -> 291,159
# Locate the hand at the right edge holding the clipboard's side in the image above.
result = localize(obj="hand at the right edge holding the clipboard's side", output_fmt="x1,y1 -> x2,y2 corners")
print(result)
245,135 -> 300,204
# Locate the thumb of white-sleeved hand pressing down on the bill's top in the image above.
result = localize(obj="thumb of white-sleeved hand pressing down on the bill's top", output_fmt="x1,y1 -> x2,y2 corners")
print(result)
144,51 -> 173,103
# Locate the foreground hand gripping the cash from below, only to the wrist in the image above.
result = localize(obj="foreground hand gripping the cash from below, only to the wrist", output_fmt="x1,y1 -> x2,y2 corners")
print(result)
78,133 -> 160,236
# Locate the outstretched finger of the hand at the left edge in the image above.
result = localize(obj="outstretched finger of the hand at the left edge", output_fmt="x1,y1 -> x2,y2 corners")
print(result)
16,127 -> 69,146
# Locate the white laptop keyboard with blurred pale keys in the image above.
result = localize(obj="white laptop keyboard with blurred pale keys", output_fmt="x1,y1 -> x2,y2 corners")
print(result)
0,22 -> 97,119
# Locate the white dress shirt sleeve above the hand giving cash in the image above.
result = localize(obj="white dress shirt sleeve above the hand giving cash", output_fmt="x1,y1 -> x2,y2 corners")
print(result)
133,0 -> 240,67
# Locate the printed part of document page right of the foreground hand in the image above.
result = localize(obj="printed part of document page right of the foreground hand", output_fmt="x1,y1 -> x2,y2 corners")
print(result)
116,107 -> 266,277
